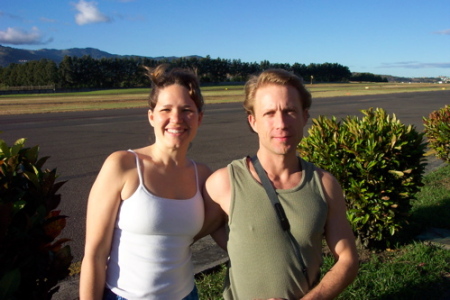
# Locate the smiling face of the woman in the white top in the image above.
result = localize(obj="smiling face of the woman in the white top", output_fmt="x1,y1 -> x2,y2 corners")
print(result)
149,84 -> 203,149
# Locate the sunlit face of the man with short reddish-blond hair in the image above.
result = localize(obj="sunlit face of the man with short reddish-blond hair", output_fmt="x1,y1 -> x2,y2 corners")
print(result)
248,84 -> 308,155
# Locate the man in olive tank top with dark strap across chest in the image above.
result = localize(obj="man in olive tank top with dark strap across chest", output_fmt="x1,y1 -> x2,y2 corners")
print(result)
204,70 -> 358,300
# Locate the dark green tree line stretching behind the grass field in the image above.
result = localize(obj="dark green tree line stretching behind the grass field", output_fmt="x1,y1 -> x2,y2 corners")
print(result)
0,55 -> 382,89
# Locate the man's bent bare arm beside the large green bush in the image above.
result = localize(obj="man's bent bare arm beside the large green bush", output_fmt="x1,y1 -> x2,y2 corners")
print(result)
302,170 -> 359,300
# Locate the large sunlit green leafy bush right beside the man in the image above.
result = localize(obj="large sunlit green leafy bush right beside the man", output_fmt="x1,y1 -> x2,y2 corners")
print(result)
298,108 -> 426,248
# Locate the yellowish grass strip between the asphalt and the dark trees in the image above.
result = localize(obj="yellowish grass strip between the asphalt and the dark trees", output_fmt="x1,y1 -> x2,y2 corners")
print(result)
0,83 -> 450,115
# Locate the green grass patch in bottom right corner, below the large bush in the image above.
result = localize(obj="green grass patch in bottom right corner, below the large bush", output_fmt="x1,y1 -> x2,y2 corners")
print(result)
336,242 -> 450,300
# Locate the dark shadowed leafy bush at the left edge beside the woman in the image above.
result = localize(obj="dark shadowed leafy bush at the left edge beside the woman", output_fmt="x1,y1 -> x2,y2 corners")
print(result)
0,139 -> 72,299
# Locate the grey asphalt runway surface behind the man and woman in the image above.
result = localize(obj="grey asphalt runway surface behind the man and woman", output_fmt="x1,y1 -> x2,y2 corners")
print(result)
0,90 -> 450,262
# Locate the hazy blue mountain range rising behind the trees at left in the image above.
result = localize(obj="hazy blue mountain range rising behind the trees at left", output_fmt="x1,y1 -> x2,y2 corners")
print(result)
0,45 -> 192,67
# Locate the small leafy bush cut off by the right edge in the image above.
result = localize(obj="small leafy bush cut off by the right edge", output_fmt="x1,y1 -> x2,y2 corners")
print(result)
423,105 -> 450,163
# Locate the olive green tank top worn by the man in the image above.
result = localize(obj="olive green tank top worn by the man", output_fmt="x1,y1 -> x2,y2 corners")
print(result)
223,158 -> 328,300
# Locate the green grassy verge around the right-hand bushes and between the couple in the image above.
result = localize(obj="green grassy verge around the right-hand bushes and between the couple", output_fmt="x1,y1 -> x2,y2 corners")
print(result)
196,165 -> 450,300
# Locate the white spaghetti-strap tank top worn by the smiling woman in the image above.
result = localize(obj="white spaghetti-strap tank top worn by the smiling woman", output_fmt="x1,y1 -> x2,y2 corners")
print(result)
106,150 -> 204,300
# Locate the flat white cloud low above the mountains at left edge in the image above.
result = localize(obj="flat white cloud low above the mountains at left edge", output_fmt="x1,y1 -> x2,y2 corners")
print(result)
0,27 -> 53,45
